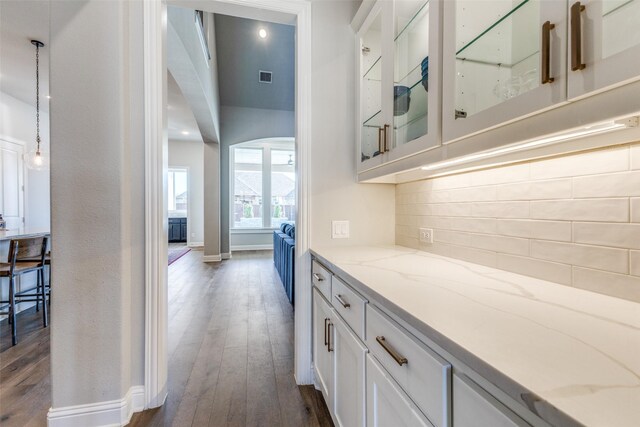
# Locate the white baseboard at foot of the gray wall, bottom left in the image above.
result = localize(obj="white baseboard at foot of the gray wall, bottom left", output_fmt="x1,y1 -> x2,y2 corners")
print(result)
47,386 -> 144,427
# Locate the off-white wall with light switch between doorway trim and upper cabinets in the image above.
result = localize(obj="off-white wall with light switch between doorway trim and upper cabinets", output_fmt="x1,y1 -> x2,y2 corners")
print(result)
310,1 -> 395,248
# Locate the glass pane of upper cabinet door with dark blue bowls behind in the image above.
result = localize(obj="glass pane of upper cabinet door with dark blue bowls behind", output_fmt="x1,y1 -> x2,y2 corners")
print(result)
392,0 -> 438,153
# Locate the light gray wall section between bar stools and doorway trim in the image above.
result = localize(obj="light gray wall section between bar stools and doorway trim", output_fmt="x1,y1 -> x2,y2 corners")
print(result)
50,0 -> 144,408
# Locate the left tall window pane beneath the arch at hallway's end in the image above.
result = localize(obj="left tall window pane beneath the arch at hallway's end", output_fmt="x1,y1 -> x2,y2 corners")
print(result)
233,148 -> 263,228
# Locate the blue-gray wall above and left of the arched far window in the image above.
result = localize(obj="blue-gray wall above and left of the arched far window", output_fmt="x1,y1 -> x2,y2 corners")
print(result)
220,105 -> 295,254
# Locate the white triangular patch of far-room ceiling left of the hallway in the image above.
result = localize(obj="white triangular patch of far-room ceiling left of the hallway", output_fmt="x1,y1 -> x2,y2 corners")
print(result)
167,72 -> 202,141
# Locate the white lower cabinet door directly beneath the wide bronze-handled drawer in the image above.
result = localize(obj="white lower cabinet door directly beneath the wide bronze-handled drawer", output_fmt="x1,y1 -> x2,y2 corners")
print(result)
367,355 -> 436,427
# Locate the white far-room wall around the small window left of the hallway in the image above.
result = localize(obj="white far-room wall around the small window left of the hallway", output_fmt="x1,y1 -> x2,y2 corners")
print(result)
169,140 -> 204,246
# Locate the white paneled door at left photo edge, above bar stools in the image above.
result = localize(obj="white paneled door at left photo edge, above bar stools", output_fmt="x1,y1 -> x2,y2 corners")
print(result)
0,140 -> 24,229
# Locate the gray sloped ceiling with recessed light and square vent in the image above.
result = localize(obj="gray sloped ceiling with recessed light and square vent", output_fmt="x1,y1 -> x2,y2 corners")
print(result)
215,14 -> 295,111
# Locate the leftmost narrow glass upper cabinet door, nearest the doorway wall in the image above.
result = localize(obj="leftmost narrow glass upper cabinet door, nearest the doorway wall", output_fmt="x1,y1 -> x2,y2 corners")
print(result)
358,2 -> 386,170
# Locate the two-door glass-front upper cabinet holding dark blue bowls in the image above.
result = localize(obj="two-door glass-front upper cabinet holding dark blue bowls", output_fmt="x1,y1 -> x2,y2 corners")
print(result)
357,0 -> 441,172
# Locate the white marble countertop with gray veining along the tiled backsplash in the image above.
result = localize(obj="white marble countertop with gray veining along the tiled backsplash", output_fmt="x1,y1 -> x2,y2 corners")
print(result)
311,246 -> 640,427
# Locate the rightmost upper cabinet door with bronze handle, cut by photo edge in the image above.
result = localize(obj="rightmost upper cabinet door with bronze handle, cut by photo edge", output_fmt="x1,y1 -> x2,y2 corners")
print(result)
568,0 -> 640,99
